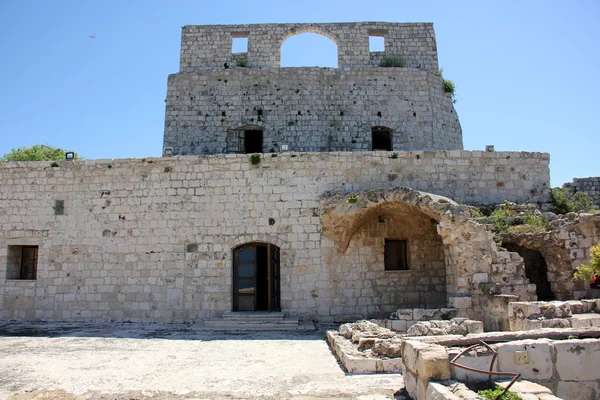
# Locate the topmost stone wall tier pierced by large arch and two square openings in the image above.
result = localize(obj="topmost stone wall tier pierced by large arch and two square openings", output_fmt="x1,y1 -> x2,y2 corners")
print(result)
180,22 -> 438,72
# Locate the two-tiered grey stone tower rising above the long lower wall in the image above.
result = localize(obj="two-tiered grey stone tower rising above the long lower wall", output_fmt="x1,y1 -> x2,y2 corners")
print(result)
164,22 -> 463,155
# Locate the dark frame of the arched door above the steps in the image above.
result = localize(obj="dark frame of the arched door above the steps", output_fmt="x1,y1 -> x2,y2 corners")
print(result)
231,242 -> 281,312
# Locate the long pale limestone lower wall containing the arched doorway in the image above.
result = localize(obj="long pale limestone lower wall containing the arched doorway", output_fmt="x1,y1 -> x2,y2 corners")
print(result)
0,151 -> 549,322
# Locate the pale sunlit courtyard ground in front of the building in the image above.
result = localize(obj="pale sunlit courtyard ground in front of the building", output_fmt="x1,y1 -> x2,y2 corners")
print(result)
0,322 -> 403,400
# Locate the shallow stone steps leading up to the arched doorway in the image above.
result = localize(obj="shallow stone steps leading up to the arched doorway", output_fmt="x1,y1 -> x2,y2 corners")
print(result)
190,311 -> 315,331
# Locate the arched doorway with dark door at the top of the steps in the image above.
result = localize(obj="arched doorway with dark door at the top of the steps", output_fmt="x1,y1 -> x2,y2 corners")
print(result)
232,243 -> 281,311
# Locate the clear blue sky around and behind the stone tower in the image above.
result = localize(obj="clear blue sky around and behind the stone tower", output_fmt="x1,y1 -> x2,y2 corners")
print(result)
0,0 -> 600,186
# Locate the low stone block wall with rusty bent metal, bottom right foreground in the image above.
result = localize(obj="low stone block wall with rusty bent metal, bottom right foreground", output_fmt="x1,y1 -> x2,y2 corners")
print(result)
402,333 -> 600,400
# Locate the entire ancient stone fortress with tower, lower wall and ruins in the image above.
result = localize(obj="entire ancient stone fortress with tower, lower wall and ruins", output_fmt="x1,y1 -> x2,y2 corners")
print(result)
0,22 -> 600,400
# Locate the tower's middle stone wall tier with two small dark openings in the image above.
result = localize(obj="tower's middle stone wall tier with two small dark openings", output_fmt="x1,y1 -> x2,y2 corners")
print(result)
164,67 -> 463,155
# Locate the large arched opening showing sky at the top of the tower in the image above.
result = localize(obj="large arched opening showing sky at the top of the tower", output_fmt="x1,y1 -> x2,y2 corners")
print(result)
281,32 -> 338,68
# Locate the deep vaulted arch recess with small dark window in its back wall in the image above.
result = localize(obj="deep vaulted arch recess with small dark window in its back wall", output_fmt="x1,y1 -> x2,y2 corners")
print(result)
323,190 -> 448,318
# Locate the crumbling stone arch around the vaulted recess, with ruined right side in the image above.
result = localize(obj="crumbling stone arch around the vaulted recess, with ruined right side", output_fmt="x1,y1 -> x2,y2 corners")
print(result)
322,188 -> 535,326
